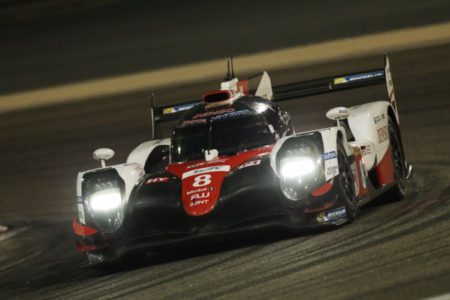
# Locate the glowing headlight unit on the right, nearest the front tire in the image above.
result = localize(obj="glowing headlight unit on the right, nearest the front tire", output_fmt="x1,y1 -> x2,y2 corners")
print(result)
277,135 -> 323,201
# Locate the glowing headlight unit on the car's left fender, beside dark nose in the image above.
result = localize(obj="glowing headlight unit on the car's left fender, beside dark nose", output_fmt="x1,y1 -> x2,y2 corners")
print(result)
82,169 -> 125,233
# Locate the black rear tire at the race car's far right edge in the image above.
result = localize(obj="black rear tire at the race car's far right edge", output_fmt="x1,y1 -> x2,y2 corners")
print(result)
387,117 -> 407,201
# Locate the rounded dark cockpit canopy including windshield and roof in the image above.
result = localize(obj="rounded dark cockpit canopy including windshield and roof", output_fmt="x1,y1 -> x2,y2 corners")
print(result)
171,96 -> 292,162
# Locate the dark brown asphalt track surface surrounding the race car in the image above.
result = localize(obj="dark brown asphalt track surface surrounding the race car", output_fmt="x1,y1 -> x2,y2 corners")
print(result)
0,44 -> 450,299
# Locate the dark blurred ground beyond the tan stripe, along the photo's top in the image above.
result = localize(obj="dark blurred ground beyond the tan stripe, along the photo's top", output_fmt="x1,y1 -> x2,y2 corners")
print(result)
0,0 -> 450,94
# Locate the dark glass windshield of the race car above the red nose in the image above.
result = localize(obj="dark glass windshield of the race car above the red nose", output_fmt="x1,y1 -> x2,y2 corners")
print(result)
172,115 -> 275,162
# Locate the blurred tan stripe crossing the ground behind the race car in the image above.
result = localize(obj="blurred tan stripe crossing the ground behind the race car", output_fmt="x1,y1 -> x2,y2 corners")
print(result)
0,22 -> 450,113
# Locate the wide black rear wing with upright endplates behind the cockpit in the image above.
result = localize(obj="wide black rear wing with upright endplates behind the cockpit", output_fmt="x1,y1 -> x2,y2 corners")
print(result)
151,53 -> 397,138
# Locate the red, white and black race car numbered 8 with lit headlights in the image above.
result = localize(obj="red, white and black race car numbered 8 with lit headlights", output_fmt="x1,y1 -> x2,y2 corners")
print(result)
73,55 -> 412,266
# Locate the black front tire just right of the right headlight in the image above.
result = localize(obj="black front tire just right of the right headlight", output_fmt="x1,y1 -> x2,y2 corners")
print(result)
335,139 -> 359,223
